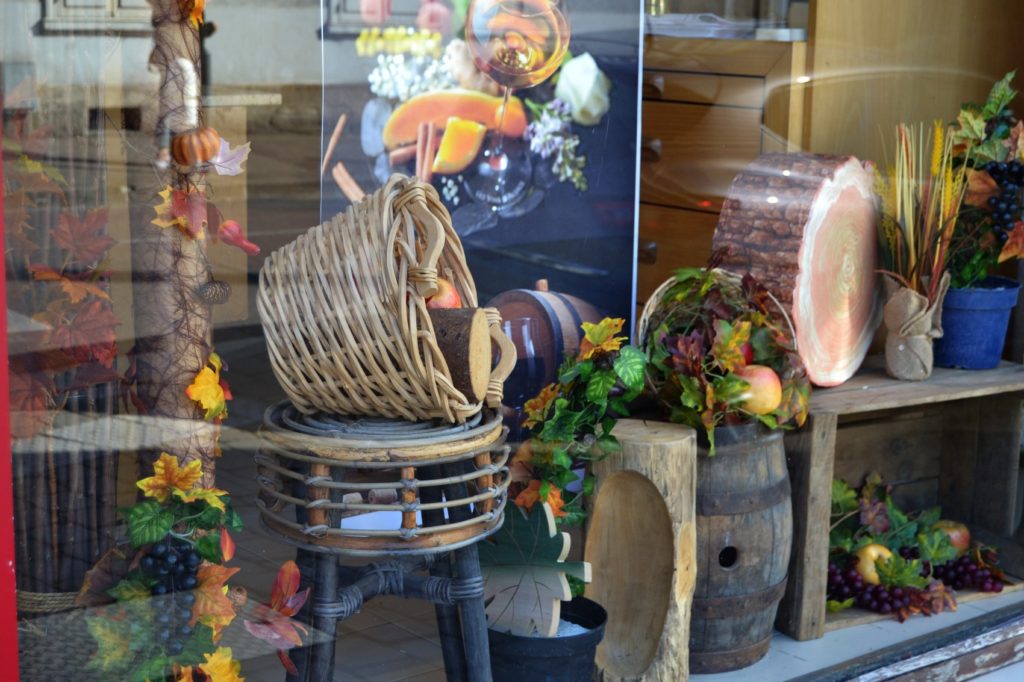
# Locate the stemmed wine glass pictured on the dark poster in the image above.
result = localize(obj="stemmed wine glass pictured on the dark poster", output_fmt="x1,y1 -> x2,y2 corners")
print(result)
466,0 -> 569,211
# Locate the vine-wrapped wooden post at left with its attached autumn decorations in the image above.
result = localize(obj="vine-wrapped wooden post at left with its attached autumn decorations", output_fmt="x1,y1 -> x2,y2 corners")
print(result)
128,0 -> 217,485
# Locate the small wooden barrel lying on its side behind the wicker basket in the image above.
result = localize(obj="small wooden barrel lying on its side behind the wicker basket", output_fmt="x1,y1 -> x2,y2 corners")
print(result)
486,280 -> 604,388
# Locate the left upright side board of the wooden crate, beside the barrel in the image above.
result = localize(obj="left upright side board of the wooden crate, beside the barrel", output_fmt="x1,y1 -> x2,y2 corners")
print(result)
775,413 -> 838,640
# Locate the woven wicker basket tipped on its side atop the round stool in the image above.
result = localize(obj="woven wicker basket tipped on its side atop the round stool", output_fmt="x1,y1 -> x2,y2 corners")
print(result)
257,175 -> 515,424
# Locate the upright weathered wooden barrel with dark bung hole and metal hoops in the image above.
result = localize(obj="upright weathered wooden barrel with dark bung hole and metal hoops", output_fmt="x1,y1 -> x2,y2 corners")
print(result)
690,424 -> 793,674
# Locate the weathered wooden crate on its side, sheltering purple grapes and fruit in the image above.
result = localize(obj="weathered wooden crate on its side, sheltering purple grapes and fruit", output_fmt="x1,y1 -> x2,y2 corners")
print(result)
775,358 -> 1024,640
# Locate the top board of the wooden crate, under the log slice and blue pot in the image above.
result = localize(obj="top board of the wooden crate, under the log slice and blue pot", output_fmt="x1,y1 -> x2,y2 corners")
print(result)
811,356 -> 1024,415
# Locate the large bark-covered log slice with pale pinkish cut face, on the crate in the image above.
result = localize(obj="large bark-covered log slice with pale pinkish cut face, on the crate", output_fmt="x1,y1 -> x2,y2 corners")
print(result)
714,154 -> 882,386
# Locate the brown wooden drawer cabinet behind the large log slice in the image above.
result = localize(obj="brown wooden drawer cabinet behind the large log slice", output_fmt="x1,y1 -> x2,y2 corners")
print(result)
637,36 -> 805,303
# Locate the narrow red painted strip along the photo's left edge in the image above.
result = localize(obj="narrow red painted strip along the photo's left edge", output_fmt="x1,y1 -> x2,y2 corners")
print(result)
0,120 -> 17,682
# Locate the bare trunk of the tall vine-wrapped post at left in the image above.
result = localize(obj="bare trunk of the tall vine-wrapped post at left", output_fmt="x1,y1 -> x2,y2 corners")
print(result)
128,0 -> 216,485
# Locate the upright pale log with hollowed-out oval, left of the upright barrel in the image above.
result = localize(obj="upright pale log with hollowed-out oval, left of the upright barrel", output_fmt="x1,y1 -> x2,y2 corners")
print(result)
586,419 -> 697,682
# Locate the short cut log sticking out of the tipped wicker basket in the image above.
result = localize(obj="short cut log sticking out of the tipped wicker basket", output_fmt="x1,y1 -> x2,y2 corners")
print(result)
428,308 -> 490,401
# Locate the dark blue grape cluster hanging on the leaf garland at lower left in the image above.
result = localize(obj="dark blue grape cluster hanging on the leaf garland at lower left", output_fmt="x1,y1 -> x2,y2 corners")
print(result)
139,537 -> 202,655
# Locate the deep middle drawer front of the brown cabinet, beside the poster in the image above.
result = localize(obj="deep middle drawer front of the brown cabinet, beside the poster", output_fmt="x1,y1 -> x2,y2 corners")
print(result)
640,101 -> 761,212
